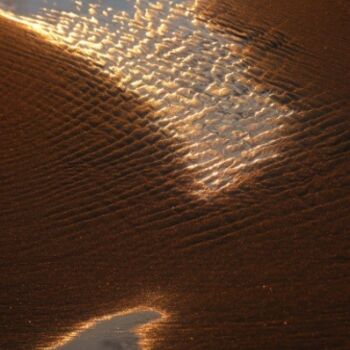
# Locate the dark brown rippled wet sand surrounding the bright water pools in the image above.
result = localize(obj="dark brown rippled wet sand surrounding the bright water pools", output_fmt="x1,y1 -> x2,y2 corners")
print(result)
0,1 -> 350,350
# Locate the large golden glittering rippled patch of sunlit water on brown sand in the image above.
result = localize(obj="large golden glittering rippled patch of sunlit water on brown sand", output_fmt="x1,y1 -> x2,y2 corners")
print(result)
1,0 -> 293,197
